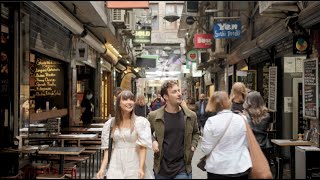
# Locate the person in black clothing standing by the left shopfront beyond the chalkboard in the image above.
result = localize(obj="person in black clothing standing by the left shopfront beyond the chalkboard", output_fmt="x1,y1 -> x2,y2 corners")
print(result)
81,90 -> 94,126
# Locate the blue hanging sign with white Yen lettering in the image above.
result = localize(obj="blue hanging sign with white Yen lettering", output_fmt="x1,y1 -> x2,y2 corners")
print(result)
213,21 -> 241,39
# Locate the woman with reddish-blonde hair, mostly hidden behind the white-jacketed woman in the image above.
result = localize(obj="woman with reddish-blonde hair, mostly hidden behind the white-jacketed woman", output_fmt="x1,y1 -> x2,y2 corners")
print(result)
230,82 -> 247,114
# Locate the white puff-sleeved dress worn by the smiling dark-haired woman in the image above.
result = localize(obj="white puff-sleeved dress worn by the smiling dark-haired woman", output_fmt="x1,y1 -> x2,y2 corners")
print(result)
101,116 -> 154,179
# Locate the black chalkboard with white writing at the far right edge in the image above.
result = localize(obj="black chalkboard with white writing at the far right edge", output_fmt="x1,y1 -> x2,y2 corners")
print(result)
303,58 -> 319,119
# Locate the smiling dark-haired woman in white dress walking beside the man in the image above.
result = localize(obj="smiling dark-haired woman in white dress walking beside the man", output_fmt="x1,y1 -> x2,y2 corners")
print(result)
97,90 -> 154,179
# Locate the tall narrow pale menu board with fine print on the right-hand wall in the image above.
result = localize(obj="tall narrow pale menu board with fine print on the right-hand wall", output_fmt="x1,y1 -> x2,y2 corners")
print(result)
268,66 -> 277,112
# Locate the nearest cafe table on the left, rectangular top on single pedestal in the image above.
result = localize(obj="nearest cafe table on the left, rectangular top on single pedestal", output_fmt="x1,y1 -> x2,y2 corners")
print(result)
38,147 -> 85,174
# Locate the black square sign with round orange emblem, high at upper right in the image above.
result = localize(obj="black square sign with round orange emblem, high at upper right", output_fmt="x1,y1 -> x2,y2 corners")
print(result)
292,35 -> 311,55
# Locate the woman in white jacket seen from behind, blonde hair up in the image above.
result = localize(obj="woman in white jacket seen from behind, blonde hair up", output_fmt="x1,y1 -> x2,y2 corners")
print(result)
201,91 -> 252,179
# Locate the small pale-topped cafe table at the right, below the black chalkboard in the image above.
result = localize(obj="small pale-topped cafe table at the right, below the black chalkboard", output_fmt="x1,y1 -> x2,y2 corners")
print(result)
271,139 -> 312,179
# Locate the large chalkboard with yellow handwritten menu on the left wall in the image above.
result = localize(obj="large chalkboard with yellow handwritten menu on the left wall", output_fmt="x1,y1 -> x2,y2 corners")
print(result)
30,53 -> 67,110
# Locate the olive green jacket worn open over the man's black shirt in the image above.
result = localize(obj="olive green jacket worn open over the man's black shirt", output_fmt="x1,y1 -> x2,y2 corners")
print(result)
148,106 -> 200,174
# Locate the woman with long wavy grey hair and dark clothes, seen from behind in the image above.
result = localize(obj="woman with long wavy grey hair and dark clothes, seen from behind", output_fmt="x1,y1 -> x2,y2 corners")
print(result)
243,91 -> 272,158
